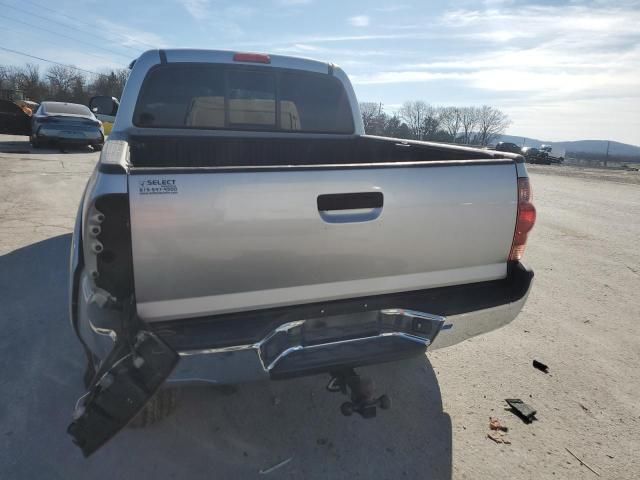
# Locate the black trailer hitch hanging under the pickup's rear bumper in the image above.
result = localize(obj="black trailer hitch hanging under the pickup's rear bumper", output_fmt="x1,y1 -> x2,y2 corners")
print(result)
327,368 -> 391,418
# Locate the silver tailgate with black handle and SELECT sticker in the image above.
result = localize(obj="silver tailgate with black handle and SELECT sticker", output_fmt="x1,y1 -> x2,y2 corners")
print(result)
129,161 -> 517,321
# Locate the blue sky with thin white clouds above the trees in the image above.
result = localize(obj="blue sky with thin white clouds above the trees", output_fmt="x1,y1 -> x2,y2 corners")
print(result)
0,0 -> 640,145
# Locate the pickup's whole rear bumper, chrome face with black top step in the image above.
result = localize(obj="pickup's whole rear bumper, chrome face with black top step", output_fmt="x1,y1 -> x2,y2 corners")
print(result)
79,263 -> 533,384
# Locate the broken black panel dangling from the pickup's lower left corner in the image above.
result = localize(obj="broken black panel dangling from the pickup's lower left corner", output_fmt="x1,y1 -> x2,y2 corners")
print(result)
67,325 -> 179,457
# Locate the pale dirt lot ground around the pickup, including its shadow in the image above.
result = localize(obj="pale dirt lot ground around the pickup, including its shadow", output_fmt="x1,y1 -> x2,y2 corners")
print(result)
0,137 -> 640,480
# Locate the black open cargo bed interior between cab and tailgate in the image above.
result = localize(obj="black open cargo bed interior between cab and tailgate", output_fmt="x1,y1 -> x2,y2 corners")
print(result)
129,133 -> 514,168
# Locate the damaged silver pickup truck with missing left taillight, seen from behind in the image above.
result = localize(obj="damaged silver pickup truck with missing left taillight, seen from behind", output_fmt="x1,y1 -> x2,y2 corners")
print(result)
68,50 -> 535,455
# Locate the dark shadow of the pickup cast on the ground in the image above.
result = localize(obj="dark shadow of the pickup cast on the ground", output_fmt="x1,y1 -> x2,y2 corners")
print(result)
0,235 -> 452,480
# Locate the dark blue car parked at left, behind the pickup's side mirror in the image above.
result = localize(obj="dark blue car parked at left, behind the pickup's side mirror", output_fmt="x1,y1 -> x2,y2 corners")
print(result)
31,102 -> 104,150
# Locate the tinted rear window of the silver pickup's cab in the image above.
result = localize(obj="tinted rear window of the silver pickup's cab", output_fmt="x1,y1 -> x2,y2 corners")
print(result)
133,64 -> 354,134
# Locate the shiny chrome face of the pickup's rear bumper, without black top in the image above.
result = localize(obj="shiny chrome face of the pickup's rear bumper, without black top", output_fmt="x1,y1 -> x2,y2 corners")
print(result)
78,266 -> 533,384
